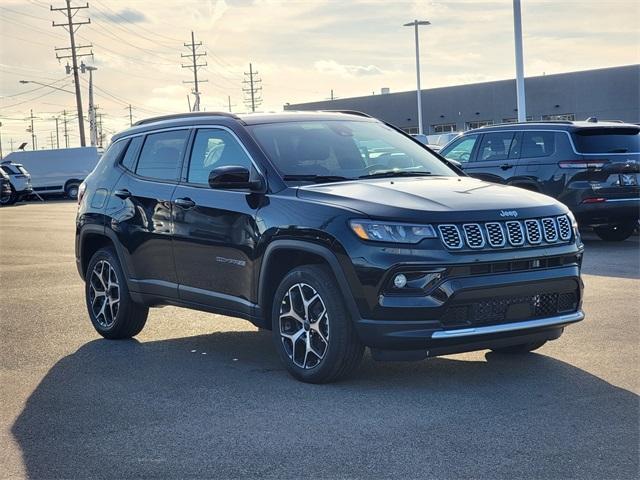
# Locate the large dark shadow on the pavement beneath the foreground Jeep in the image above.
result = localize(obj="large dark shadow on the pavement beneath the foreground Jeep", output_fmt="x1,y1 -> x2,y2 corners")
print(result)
12,331 -> 639,478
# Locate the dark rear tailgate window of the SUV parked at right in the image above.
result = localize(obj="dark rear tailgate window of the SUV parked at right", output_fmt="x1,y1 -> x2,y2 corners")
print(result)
573,127 -> 640,153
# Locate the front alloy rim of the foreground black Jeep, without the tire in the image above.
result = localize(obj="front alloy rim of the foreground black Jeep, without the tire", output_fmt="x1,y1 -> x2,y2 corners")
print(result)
278,283 -> 329,369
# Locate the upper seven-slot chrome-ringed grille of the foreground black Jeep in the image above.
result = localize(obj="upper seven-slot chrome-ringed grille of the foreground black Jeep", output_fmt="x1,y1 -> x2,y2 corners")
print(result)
438,215 -> 572,250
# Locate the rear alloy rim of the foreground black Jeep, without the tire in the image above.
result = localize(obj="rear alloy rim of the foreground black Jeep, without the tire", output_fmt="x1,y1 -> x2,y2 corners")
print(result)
89,260 -> 120,328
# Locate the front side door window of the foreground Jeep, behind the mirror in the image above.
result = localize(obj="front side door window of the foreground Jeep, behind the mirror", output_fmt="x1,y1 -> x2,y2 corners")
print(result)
187,129 -> 251,185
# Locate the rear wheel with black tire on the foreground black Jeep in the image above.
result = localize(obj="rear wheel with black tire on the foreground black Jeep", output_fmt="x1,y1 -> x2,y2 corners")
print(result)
85,248 -> 149,340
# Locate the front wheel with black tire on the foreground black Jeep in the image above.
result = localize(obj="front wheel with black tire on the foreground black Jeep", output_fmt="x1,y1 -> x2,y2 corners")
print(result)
271,265 -> 364,383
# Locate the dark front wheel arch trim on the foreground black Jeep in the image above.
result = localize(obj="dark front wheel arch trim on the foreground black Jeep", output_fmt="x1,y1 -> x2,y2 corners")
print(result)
258,240 -> 360,328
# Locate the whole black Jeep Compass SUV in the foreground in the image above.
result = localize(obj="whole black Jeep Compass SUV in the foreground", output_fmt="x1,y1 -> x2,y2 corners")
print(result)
76,112 -> 584,382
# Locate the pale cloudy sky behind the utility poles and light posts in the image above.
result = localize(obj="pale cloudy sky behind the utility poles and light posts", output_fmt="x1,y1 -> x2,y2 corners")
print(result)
0,0 -> 640,148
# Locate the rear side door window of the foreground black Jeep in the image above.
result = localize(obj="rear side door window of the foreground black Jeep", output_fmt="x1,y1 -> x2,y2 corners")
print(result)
136,130 -> 189,180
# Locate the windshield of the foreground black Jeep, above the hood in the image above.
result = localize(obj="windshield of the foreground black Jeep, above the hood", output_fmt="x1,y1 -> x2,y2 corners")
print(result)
250,120 -> 457,181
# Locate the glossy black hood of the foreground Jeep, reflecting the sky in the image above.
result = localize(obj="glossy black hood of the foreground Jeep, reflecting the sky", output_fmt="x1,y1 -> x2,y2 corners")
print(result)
297,176 -> 567,222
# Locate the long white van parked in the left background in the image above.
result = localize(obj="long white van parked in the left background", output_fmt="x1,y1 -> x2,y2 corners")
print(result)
4,147 -> 100,198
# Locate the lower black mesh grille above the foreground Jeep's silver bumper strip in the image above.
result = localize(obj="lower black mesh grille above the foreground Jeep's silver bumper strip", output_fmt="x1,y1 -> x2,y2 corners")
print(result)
440,292 -> 578,326
